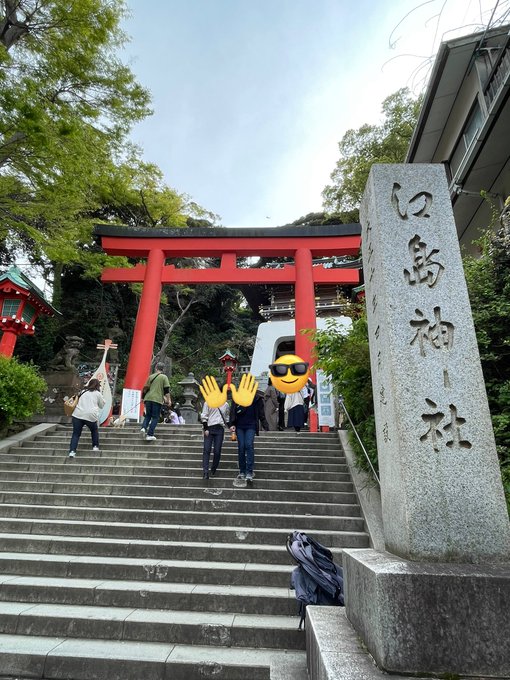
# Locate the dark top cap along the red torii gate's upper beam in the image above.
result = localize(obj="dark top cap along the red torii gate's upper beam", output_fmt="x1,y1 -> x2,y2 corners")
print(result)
94,223 -> 361,239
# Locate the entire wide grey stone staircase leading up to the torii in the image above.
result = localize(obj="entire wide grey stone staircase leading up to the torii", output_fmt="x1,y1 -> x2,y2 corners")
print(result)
0,425 -> 368,680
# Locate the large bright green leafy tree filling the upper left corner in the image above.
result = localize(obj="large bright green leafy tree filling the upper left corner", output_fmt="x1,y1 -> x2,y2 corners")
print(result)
0,0 -> 150,278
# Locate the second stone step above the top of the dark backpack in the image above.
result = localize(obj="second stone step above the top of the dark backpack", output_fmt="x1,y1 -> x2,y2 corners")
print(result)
0,491 -> 361,517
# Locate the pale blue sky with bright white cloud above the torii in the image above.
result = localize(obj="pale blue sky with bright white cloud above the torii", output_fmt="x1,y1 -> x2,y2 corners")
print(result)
120,0 -> 510,227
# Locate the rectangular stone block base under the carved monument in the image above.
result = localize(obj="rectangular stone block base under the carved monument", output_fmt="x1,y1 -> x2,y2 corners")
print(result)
343,549 -> 510,678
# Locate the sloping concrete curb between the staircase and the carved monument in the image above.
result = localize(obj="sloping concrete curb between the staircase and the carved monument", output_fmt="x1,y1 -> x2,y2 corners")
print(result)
338,430 -> 386,552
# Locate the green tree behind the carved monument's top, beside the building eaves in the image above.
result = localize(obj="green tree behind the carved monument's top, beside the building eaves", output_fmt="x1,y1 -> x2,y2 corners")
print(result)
322,88 -> 421,223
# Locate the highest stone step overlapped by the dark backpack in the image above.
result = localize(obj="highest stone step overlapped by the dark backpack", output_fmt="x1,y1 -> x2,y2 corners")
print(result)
0,507 -> 367,548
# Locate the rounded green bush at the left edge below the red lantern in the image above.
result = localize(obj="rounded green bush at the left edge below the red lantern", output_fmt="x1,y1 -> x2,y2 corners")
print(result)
0,354 -> 47,433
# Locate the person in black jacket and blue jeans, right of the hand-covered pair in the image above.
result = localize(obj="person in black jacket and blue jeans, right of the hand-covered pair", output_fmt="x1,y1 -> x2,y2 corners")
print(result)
229,394 -> 269,482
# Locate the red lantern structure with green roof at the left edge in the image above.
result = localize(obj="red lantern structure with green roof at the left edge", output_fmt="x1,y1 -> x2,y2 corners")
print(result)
0,266 -> 60,357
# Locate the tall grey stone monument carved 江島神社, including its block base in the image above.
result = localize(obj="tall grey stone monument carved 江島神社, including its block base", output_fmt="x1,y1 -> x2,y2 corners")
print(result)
344,164 -> 510,677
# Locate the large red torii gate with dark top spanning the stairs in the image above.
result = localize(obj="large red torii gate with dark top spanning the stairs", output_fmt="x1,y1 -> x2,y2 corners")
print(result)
94,224 -> 361,390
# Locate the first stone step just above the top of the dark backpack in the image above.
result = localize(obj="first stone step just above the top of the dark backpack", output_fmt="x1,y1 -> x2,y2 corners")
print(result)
0,503 -> 364,532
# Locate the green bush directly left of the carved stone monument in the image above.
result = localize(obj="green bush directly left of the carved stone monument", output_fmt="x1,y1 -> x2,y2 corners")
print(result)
314,310 -> 377,472
